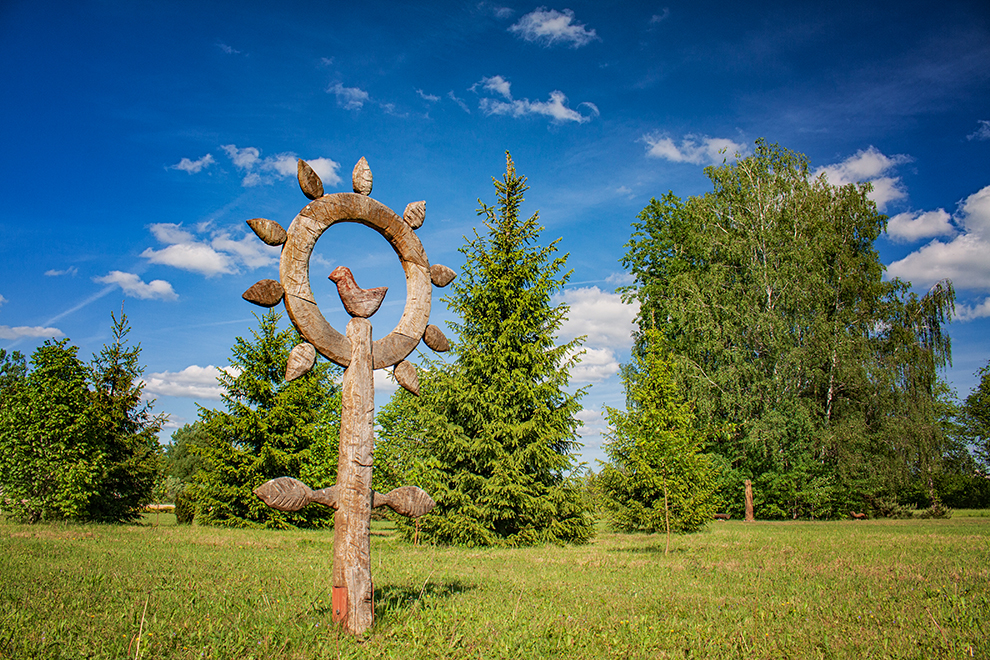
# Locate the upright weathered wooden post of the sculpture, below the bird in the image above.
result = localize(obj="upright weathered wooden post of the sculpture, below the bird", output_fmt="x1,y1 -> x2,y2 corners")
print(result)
333,318 -> 375,634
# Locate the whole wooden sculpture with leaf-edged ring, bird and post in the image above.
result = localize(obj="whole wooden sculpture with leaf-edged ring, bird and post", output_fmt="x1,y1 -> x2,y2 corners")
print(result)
244,158 -> 455,634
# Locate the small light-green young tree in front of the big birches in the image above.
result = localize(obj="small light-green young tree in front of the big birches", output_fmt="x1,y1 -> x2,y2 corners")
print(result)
599,329 -> 718,533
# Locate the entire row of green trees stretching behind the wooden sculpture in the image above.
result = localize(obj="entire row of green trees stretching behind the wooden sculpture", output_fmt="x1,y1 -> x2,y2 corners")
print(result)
0,140 -> 990,532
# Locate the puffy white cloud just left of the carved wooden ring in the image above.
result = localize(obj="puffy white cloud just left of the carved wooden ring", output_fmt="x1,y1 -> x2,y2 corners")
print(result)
141,222 -> 280,277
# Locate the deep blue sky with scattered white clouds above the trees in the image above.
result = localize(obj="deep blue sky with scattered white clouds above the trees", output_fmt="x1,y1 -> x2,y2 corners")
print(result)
0,0 -> 990,461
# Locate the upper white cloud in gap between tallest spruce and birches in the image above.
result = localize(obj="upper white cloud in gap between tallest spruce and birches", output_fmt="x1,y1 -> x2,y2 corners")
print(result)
554,286 -> 639,350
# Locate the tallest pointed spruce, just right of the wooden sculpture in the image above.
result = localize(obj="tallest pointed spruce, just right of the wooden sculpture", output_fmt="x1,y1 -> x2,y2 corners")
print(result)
379,154 -> 593,546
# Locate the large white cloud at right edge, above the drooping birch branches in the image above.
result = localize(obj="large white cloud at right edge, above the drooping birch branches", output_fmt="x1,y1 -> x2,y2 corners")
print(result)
887,186 -> 990,292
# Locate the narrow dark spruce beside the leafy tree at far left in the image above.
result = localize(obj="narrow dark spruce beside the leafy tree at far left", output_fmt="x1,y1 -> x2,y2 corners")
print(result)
86,311 -> 165,522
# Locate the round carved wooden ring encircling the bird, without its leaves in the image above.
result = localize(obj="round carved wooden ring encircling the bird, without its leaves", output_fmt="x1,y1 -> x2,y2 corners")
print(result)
279,193 -> 433,369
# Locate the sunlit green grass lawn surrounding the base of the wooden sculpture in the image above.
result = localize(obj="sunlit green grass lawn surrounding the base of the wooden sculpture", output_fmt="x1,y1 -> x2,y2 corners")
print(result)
0,512 -> 990,659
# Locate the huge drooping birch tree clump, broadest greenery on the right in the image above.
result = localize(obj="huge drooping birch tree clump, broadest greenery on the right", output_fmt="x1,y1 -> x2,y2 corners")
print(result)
623,140 -> 954,517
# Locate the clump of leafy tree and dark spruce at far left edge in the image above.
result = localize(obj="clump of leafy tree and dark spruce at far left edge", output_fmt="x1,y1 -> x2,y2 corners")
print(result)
0,314 -> 163,523
